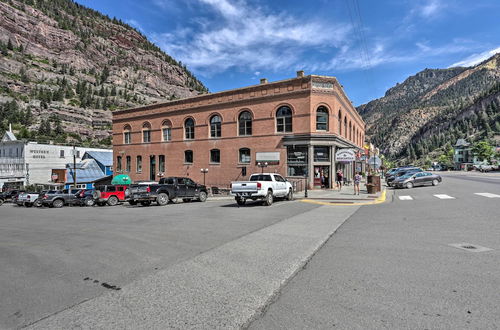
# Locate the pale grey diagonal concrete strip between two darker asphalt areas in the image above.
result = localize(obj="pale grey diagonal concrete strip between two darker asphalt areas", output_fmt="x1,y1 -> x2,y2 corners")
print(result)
28,206 -> 358,329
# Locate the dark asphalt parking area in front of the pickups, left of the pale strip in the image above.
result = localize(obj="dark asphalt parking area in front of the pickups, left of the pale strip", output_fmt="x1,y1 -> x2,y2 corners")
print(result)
0,199 -> 318,328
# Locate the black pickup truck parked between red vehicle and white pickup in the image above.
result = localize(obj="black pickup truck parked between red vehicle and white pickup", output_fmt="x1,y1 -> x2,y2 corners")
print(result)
127,177 -> 207,206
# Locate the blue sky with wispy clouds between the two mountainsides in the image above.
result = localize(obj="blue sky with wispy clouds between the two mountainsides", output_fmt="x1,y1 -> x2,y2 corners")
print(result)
77,0 -> 500,105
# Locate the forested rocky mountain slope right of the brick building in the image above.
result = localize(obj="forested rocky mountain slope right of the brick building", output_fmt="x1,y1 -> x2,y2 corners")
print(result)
358,54 -> 500,161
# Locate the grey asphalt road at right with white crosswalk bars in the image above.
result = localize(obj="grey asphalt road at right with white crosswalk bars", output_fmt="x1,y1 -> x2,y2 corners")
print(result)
250,173 -> 500,329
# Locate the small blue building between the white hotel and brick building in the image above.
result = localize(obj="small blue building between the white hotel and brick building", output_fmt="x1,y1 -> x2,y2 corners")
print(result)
65,150 -> 113,189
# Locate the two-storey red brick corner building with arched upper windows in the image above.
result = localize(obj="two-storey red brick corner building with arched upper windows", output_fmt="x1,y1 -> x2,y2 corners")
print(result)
113,71 -> 365,191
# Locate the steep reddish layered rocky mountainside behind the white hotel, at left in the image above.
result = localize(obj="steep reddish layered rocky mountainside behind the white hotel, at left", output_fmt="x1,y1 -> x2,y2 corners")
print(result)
0,0 -> 208,145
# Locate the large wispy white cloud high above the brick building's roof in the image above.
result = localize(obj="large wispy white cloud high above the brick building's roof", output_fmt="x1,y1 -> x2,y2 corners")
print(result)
151,0 -> 350,74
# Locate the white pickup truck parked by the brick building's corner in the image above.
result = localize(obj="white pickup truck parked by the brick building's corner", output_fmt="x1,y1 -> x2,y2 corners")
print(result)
231,173 -> 293,206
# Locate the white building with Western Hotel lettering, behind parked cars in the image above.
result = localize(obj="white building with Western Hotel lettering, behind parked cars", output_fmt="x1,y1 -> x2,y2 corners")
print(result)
0,131 -> 113,189
